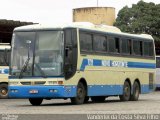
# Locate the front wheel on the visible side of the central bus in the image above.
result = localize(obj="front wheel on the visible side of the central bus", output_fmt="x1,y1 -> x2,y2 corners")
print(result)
71,82 -> 86,105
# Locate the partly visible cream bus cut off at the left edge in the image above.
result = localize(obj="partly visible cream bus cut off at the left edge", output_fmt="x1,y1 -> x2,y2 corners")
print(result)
0,43 -> 11,98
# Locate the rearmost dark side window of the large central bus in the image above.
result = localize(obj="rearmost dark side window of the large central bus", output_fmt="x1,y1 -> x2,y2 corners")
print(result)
144,42 -> 153,56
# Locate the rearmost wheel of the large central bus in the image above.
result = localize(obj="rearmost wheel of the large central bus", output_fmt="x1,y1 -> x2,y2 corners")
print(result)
130,81 -> 140,101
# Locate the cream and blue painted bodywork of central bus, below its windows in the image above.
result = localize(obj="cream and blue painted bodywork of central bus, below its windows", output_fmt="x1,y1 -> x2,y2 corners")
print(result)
9,23 -> 156,98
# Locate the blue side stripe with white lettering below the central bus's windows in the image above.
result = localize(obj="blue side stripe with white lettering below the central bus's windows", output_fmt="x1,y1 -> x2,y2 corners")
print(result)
80,59 -> 156,71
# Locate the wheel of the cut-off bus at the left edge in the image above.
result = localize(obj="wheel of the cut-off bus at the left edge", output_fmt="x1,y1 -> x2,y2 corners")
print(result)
0,83 -> 8,99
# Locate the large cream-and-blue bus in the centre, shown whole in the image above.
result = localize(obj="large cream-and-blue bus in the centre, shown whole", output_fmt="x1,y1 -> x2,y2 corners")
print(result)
9,22 -> 156,105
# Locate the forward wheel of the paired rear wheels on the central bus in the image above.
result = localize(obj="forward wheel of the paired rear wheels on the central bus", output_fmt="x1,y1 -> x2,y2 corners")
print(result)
119,81 -> 131,101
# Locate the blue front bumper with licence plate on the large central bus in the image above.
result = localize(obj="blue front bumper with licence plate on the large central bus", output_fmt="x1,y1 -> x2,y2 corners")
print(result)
9,86 -> 76,98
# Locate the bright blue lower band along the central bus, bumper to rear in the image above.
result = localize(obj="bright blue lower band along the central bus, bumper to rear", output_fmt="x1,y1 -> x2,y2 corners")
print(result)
9,85 -> 151,99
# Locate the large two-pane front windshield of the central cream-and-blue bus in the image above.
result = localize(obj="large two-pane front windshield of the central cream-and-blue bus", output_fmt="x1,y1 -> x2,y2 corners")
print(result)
10,31 -> 64,77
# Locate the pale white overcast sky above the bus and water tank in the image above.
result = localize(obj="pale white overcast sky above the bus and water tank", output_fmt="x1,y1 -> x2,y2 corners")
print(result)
0,0 -> 160,24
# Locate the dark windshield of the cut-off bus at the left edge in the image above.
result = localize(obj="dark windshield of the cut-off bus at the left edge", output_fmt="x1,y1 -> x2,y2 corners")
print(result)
0,49 -> 10,66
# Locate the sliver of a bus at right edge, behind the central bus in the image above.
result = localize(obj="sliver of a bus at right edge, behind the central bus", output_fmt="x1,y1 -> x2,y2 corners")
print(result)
155,55 -> 160,89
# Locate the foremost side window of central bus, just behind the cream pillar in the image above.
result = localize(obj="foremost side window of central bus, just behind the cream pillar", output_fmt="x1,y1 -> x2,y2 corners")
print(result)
80,33 -> 92,51
